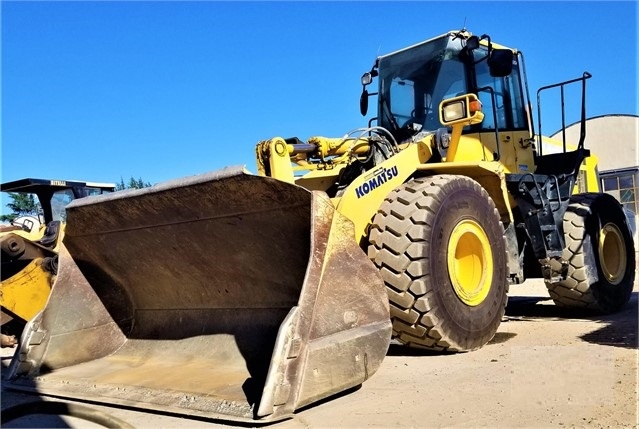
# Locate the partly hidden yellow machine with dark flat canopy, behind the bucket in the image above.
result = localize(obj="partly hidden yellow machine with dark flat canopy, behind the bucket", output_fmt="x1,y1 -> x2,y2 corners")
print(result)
0,178 -> 115,336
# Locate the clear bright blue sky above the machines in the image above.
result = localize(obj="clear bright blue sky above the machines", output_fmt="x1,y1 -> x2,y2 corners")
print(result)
0,1 -> 638,212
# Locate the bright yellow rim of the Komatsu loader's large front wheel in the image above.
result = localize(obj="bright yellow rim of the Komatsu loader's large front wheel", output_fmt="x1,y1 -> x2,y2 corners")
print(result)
447,220 -> 493,307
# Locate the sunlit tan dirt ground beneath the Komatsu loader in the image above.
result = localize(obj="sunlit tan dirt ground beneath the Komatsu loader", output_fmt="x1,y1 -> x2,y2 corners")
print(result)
1,281 -> 639,429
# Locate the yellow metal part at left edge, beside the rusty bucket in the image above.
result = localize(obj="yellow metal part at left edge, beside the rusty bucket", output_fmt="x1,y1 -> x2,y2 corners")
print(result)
0,258 -> 53,321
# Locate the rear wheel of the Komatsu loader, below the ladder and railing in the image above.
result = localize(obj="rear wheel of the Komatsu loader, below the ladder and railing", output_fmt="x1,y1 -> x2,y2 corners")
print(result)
546,194 -> 635,313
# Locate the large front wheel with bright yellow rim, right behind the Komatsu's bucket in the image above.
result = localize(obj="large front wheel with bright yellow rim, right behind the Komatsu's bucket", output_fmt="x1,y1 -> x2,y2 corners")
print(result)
368,175 -> 508,351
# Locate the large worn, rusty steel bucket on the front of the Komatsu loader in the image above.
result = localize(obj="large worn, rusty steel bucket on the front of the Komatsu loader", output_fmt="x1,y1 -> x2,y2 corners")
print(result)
9,168 -> 391,422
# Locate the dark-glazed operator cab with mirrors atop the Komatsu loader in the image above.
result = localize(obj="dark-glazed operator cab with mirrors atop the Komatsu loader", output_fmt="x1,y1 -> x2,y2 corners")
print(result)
361,31 -> 531,145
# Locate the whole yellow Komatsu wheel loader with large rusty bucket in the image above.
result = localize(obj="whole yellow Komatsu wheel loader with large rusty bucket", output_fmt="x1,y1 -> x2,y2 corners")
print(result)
5,30 -> 635,422
